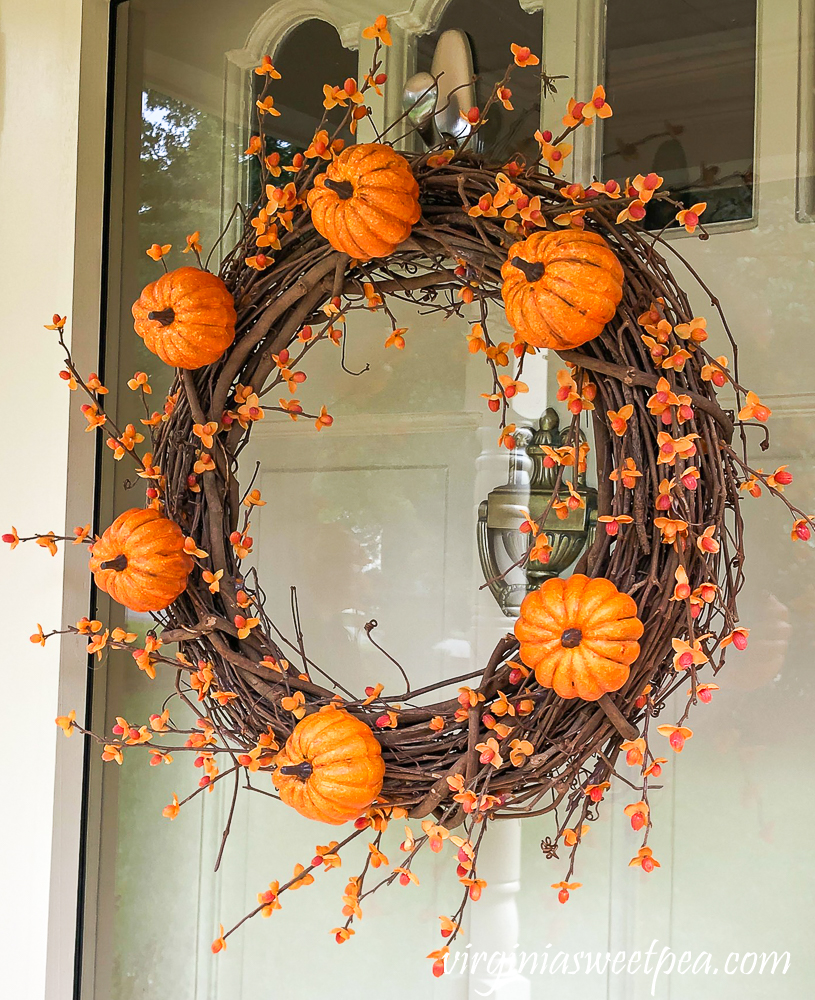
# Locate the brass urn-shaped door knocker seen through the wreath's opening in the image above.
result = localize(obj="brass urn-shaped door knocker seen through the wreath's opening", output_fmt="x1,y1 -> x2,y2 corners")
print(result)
477,407 -> 597,618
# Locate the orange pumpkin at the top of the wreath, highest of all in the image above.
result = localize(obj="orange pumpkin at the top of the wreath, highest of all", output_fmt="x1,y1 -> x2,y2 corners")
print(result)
308,142 -> 422,260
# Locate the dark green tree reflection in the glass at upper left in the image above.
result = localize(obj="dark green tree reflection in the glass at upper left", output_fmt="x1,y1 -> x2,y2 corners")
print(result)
138,90 -> 225,273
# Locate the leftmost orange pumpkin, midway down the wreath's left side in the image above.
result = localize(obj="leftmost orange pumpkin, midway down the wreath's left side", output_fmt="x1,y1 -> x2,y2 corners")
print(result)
90,507 -> 193,611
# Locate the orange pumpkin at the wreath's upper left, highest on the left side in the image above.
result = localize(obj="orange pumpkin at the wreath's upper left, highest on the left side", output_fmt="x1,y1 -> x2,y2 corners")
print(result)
132,267 -> 237,369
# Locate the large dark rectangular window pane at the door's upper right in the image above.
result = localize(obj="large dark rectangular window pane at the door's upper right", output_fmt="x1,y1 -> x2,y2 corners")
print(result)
601,0 -> 756,229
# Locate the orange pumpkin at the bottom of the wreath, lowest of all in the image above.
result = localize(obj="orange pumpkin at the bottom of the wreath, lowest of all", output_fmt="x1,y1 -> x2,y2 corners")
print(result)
272,705 -> 385,825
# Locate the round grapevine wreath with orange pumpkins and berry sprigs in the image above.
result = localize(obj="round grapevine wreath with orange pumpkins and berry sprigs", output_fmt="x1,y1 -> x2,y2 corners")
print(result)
14,17 -> 812,974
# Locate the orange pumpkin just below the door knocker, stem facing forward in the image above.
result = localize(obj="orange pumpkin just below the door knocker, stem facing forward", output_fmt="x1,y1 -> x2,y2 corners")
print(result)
515,573 -> 643,701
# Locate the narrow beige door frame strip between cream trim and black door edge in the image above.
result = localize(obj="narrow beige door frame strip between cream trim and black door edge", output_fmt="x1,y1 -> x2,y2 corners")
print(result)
43,0 -> 111,1000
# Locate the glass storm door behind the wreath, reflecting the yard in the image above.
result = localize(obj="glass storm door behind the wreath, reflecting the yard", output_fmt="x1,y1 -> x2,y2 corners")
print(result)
82,0 -> 815,1000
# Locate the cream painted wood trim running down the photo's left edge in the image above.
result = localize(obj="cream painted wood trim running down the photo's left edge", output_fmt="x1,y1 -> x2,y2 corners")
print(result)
0,0 -> 107,1000
